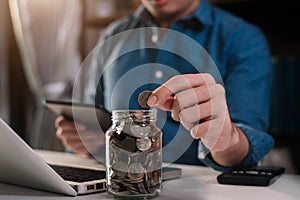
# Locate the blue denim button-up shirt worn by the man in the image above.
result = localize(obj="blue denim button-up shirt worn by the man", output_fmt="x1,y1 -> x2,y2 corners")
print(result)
85,0 -> 274,171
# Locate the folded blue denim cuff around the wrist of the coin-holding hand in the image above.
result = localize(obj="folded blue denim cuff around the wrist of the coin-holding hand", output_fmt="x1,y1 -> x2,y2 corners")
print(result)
198,124 -> 274,172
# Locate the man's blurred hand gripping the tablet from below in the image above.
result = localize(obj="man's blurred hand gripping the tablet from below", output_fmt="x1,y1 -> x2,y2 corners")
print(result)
55,116 -> 105,155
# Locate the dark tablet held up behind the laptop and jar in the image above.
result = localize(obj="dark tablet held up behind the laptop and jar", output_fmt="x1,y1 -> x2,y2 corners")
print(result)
43,100 -> 111,131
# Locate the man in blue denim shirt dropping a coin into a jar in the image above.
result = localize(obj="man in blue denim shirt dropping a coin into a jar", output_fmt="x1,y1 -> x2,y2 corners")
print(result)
56,0 -> 273,171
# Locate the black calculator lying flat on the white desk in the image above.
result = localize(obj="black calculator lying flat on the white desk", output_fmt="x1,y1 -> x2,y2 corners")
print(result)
217,166 -> 285,186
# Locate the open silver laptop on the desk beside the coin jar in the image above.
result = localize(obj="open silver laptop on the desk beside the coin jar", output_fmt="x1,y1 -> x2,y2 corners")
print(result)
0,118 -> 106,196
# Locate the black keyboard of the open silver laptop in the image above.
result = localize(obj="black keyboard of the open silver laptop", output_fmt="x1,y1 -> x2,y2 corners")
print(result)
50,165 -> 106,182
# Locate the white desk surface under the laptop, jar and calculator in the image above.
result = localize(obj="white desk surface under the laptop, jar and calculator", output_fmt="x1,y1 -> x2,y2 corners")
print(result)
0,151 -> 300,200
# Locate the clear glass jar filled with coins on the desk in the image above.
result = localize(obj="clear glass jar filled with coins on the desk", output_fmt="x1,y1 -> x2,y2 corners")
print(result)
106,110 -> 162,199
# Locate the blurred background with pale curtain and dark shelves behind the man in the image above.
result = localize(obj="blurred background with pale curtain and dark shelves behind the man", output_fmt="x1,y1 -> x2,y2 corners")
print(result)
0,0 -> 300,174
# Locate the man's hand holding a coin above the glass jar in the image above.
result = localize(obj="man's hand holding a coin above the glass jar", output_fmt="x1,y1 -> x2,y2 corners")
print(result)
147,74 -> 248,165
